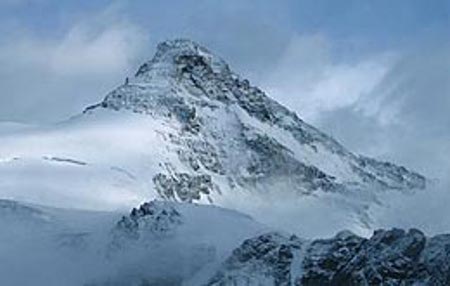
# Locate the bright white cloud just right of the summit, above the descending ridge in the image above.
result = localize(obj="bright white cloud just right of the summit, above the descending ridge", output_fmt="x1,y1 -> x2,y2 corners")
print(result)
264,34 -> 394,122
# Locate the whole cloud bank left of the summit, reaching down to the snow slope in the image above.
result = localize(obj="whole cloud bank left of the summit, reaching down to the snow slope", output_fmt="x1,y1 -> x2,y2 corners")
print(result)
0,6 -> 148,121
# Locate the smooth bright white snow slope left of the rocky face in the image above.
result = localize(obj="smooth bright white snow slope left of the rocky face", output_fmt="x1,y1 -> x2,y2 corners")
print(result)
0,111 -> 179,210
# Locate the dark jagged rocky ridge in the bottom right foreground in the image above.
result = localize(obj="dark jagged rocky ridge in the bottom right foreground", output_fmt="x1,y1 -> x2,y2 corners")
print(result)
207,229 -> 450,286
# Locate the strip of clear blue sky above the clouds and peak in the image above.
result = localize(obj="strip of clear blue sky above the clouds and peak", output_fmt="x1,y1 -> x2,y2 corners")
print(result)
0,0 -> 450,64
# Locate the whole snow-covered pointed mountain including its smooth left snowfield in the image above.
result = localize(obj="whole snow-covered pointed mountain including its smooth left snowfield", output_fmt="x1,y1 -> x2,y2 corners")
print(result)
0,40 -> 427,236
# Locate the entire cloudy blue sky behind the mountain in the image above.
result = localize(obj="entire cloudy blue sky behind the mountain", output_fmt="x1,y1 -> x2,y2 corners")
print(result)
0,0 -> 450,178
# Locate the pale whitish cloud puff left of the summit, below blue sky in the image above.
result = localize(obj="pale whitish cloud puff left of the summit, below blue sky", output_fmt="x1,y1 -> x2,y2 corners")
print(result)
0,6 -> 146,75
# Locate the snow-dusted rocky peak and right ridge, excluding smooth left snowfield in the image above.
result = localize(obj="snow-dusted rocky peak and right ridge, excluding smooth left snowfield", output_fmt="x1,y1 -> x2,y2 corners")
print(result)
87,40 -> 425,208
